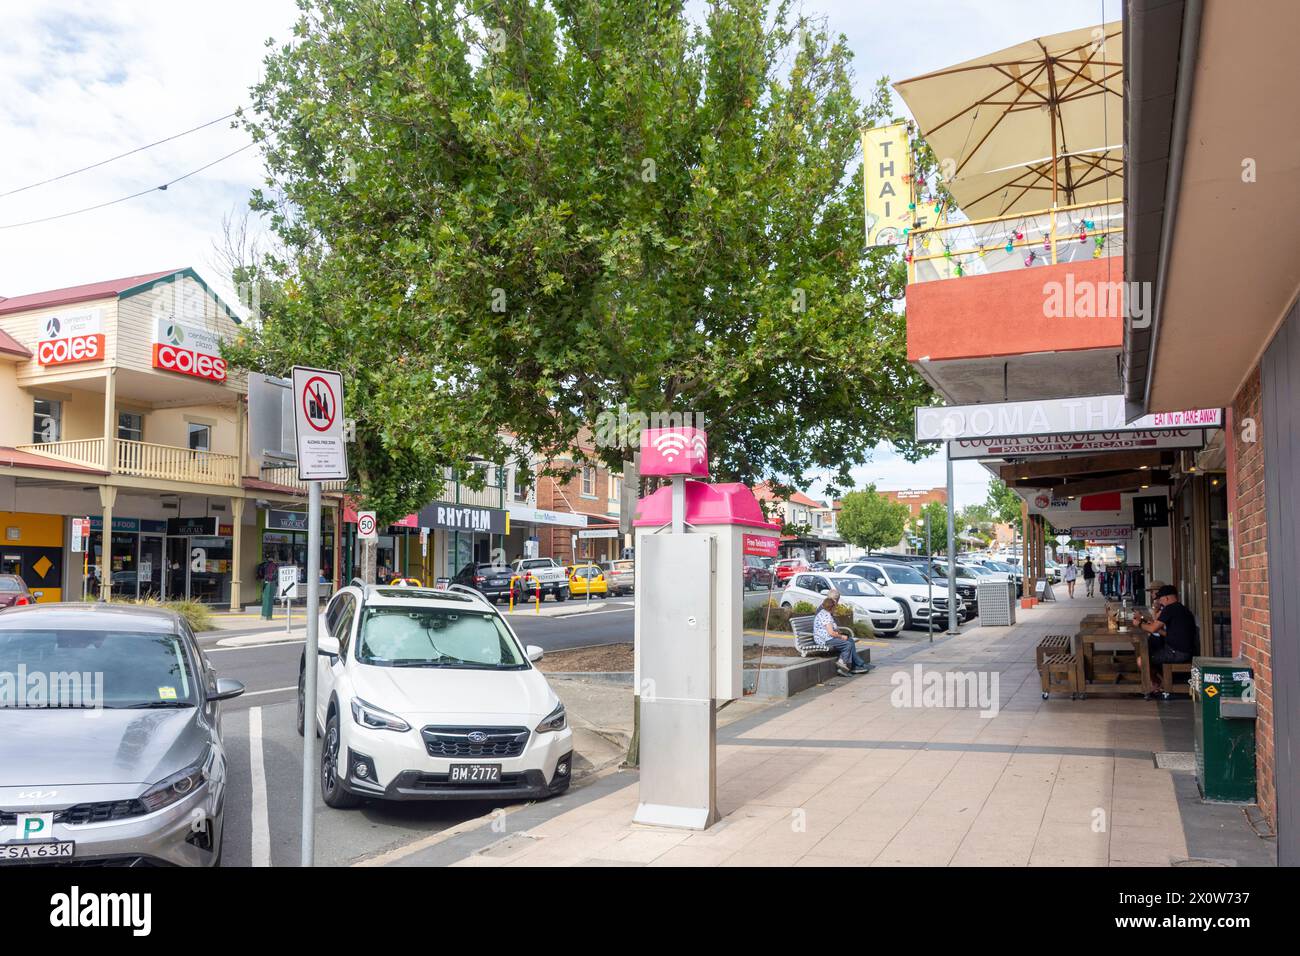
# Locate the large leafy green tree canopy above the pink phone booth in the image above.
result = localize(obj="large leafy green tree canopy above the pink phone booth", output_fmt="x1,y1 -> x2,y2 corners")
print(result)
230,0 -> 930,518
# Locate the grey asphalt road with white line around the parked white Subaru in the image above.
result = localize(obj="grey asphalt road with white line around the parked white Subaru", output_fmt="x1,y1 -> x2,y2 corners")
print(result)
200,600 -> 632,866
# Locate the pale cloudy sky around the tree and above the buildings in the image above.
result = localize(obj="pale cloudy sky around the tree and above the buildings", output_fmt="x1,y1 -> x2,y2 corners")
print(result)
0,0 -> 1121,506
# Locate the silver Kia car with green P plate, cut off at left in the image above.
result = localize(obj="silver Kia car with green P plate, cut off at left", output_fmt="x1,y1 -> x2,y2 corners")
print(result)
0,604 -> 243,866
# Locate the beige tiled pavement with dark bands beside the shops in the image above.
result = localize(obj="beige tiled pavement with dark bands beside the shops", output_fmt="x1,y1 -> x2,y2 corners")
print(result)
384,598 -> 1275,866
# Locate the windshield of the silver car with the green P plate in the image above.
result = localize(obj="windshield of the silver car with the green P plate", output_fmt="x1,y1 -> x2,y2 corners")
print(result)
0,628 -> 198,709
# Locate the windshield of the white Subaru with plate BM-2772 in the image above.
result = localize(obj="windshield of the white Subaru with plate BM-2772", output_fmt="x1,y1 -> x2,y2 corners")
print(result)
356,606 -> 528,670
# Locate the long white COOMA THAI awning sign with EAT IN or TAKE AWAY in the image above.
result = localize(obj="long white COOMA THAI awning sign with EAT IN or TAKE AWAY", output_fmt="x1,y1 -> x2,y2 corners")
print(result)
915,395 -> 1223,441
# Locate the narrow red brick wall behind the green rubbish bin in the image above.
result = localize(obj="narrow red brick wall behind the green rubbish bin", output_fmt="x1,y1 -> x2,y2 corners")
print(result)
1229,367 -> 1277,827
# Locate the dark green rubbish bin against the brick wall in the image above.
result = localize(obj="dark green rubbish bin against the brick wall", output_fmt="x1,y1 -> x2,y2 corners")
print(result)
1190,657 -> 1255,804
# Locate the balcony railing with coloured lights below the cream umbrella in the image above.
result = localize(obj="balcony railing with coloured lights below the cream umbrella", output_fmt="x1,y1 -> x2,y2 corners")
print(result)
907,199 -> 1125,282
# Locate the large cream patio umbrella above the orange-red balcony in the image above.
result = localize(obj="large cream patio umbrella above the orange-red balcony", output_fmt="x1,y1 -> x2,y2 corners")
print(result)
894,23 -> 1123,219
